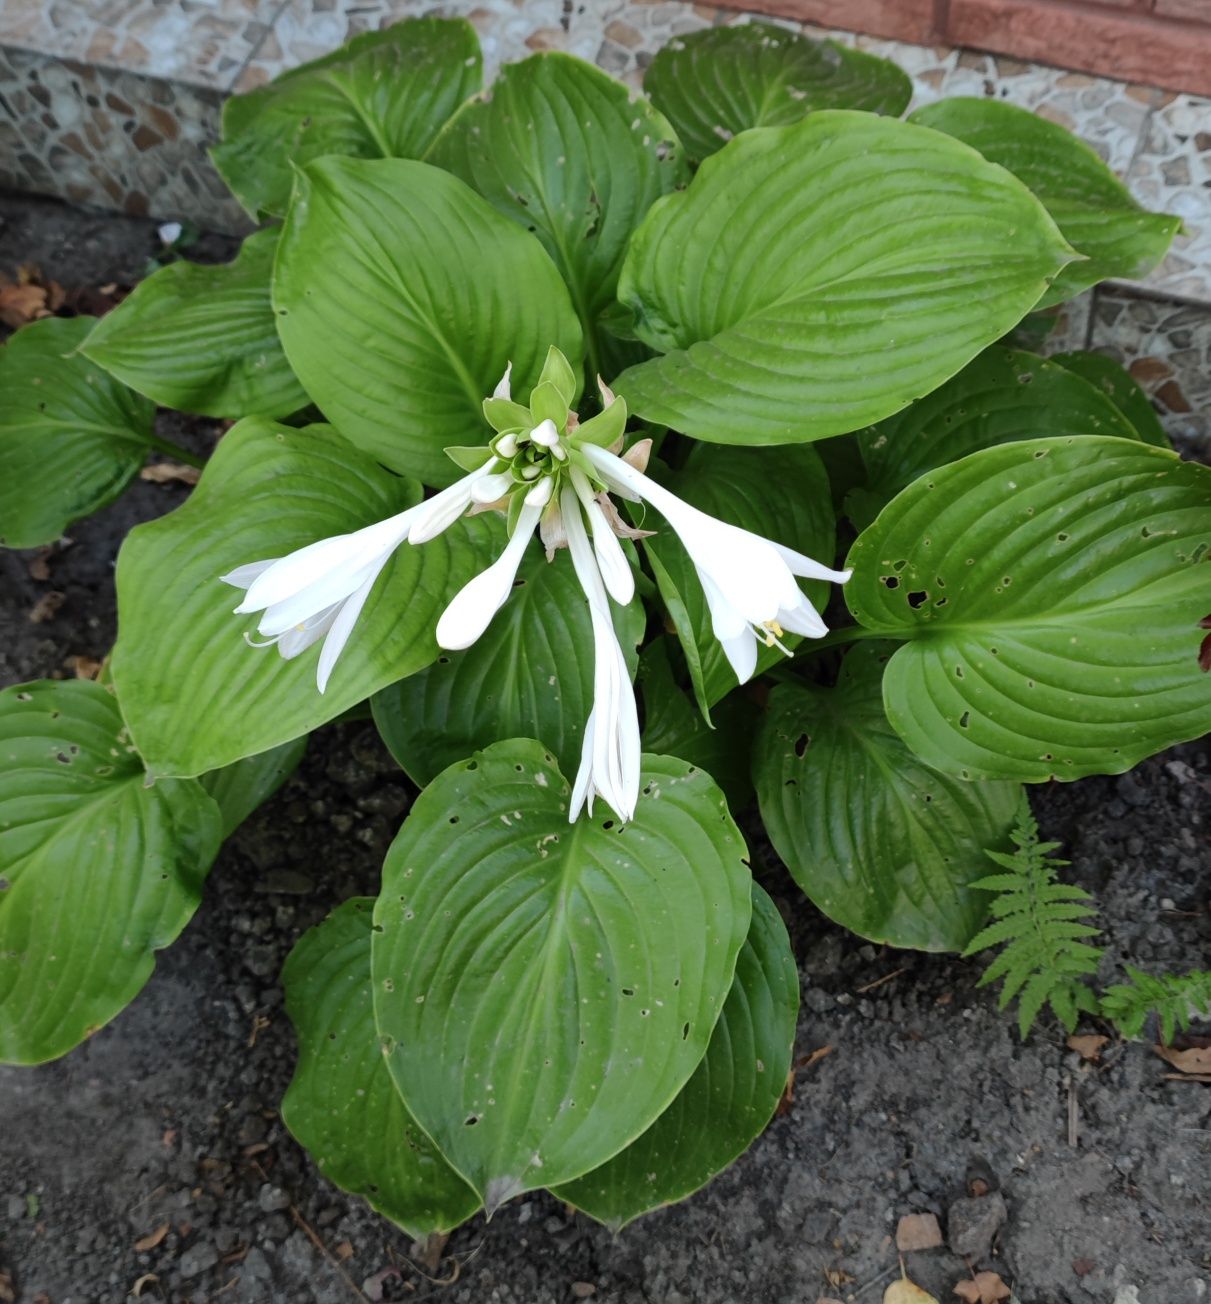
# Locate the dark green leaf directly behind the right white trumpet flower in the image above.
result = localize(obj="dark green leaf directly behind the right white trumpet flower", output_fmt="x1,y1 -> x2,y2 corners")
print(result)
643,447 -> 837,715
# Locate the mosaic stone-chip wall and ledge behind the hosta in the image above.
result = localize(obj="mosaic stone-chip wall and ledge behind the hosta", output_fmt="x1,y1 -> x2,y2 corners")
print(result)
0,0 -> 1211,455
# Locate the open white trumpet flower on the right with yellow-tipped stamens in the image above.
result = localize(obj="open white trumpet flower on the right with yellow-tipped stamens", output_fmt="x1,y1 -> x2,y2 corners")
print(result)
583,445 -> 851,683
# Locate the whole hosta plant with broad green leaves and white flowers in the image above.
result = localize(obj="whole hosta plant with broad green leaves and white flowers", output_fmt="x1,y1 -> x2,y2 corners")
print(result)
0,18 -> 1211,1234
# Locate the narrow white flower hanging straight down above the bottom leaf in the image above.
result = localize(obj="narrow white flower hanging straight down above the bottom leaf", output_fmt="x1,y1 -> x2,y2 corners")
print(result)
561,489 -> 641,823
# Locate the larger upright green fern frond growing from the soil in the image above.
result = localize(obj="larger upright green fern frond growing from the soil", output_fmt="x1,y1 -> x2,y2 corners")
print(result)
963,793 -> 1102,1041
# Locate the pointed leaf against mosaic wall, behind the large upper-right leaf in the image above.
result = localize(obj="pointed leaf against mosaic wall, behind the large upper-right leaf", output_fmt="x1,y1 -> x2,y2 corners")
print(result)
912,95 -> 1181,308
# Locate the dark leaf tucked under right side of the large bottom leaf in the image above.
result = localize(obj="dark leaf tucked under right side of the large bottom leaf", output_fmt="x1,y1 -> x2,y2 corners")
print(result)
553,884 -> 799,1231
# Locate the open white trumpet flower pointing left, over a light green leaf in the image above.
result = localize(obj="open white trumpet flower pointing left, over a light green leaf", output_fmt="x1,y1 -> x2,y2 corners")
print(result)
220,503 -> 428,692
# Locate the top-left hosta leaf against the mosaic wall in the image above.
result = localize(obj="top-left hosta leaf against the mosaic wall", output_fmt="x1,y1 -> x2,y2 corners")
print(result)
210,18 -> 484,220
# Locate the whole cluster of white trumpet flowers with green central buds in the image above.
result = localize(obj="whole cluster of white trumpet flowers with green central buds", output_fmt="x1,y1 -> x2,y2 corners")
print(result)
223,348 -> 850,820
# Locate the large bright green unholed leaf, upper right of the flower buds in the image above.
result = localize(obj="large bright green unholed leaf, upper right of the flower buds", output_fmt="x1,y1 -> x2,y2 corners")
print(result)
615,110 -> 1074,443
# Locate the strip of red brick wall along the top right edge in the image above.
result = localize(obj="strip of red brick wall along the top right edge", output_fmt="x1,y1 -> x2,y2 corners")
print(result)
729,0 -> 1211,95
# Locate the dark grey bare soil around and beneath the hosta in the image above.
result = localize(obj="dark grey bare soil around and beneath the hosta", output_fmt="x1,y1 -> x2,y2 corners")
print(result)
0,189 -> 1211,1304
